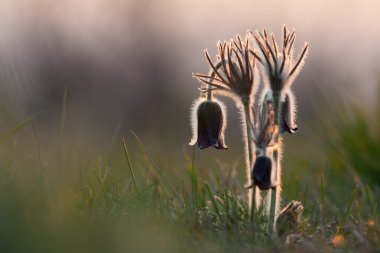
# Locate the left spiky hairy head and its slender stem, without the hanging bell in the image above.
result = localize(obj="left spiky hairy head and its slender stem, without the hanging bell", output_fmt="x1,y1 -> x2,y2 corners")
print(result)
194,36 -> 259,210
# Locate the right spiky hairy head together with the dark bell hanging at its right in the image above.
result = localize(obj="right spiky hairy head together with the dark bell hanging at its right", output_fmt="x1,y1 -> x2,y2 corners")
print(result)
251,26 -> 309,133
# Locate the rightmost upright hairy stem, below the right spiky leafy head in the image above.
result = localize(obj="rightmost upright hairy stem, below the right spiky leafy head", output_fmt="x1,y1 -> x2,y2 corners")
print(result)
268,92 -> 281,235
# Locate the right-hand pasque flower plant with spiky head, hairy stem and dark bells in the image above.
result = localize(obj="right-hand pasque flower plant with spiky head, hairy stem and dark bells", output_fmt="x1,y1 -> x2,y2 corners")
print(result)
251,26 -> 309,234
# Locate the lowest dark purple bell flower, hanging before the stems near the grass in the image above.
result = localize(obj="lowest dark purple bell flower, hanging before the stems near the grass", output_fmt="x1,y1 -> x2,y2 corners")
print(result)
252,156 -> 275,190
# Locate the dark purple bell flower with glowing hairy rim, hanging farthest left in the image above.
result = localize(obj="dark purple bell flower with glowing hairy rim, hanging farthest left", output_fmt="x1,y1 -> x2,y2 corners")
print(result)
189,98 -> 228,149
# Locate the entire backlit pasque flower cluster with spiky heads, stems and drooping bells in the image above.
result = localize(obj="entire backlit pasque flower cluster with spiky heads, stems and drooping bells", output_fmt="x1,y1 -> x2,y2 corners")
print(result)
190,26 -> 308,232
